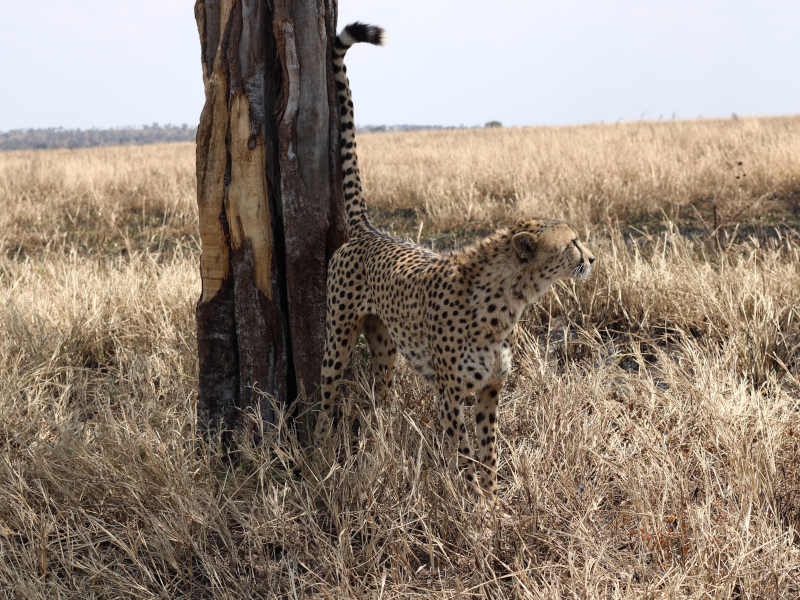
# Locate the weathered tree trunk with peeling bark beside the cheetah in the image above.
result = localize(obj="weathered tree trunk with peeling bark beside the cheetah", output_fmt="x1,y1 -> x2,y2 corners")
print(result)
195,0 -> 344,442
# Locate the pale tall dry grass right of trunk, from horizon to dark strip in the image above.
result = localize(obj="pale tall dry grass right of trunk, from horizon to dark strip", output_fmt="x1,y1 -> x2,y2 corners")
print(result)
359,117 -> 800,238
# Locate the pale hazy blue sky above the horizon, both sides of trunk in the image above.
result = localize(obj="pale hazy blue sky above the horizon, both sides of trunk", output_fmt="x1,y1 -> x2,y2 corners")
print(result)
0,0 -> 800,130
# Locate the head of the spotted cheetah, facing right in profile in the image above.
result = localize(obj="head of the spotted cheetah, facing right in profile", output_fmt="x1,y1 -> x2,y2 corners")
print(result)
510,220 -> 594,288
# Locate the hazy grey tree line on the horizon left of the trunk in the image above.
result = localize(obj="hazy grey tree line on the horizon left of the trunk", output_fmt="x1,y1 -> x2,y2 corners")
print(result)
0,123 -> 197,150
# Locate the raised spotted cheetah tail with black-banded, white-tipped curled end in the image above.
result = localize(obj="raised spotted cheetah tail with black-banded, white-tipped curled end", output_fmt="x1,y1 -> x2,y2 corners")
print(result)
333,22 -> 384,236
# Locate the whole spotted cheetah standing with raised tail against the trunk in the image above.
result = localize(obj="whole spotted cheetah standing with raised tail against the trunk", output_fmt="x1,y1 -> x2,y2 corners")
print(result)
315,23 -> 594,497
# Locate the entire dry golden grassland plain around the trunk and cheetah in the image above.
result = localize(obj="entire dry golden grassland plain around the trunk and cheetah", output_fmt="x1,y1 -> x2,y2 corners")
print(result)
0,117 -> 800,599
